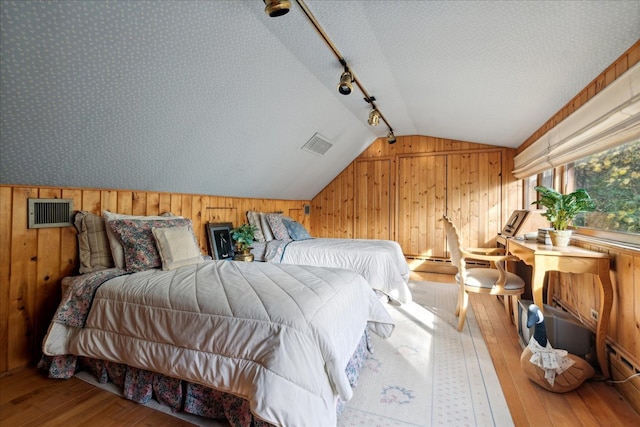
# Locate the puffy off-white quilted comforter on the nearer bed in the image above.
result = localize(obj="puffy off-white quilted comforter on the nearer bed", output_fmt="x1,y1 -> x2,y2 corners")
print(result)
43,261 -> 393,426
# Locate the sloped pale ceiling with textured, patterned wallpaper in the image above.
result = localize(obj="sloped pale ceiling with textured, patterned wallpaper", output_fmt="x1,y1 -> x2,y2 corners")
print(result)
0,0 -> 640,199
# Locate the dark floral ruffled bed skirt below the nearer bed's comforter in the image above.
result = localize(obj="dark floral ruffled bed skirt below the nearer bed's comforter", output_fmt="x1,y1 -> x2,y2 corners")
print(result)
38,330 -> 373,427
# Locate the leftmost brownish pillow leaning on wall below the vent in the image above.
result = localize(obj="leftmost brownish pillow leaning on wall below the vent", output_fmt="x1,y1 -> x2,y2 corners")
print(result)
74,211 -> 114,274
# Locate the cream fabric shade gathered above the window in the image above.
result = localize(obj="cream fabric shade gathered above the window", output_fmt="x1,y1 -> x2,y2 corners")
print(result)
513,63 -> 640,179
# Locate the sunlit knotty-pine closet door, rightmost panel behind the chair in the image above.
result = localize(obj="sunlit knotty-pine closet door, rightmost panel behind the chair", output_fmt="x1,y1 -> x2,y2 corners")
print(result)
447,151 -> 502,247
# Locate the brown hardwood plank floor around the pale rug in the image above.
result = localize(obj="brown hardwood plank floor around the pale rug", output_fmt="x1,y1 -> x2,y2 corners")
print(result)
0,273 -> 640,427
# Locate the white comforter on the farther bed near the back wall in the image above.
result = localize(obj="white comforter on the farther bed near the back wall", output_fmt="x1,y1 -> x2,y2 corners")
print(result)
280,238 -> 411,303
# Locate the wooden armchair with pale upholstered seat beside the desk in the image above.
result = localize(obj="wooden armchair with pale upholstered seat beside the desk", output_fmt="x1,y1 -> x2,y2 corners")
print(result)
442,216 -> 524,332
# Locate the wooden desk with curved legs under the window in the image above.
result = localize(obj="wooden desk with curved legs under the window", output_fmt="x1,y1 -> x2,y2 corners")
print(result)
507,238 -> 613,378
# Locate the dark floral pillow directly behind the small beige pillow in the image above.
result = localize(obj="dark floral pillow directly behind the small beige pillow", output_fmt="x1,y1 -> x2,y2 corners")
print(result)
108,218 -> 197,272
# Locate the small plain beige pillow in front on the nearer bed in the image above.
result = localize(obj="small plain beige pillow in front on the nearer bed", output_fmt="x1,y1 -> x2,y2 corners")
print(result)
151,227 -> 203,270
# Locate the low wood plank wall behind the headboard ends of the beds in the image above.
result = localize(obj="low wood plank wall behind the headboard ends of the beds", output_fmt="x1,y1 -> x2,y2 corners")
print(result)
0,185 -> 309,374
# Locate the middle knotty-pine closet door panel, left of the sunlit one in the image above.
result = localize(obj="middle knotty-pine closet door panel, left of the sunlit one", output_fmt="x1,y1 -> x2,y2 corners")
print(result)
396,154 -> 447,258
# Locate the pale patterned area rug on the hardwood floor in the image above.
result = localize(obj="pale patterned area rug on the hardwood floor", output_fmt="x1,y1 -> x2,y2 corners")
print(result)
77,281 -> 513,427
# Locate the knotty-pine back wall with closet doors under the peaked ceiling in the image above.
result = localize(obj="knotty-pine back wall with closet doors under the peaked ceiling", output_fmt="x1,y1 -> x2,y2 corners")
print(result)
311,136 -> 522,258
